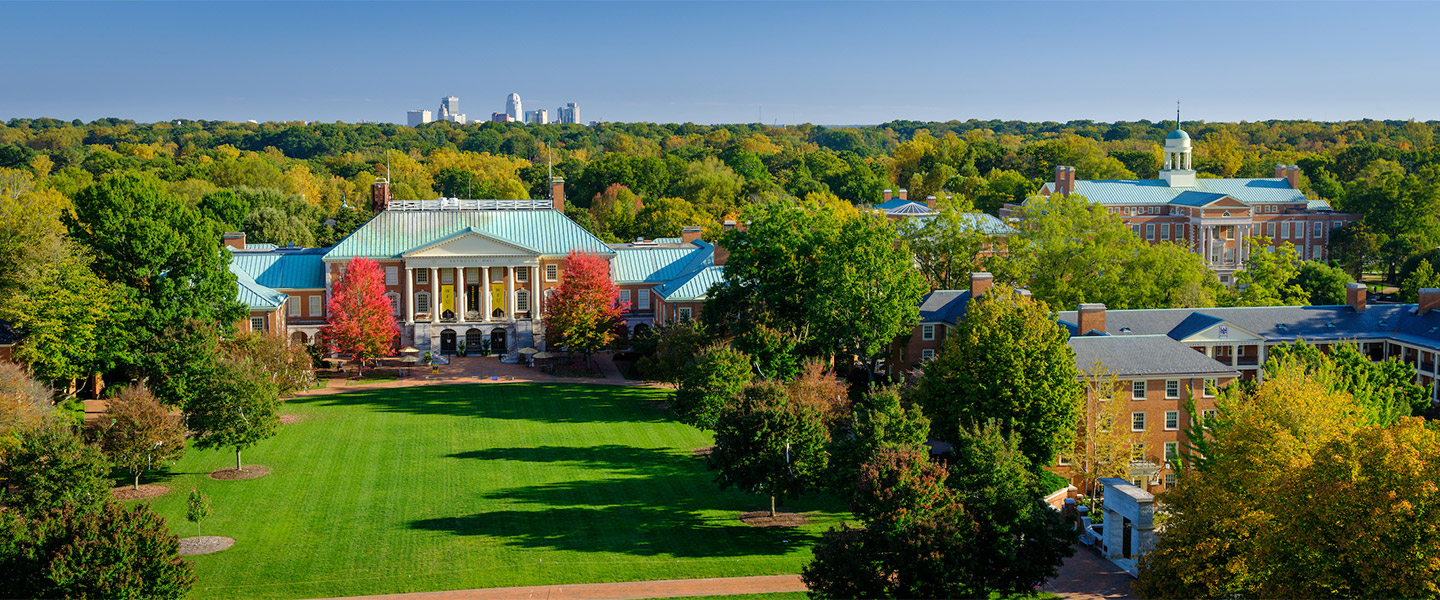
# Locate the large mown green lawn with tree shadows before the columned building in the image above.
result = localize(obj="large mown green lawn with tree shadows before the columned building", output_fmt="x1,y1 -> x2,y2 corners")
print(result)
132,384 -> 847,597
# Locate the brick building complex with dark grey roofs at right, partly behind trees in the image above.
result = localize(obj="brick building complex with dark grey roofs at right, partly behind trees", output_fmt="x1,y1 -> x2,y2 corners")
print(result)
891,273 -> 1440,489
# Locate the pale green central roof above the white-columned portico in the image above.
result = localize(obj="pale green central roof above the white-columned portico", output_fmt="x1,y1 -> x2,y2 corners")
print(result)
325,209 -> 615,260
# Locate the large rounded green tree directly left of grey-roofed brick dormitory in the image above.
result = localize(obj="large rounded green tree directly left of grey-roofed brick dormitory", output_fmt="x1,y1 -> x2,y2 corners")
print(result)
914,285 -> 1084,465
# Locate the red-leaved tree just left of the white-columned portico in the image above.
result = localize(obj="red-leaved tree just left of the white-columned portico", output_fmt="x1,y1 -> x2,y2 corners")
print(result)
320,258 -> 400,367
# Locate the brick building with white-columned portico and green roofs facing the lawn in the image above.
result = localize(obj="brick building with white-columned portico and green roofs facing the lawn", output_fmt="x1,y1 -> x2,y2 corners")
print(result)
225,178 -> 724,354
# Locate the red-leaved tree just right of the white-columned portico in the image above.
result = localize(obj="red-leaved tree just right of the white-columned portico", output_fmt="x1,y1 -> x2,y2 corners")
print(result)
544,252 -> 625,368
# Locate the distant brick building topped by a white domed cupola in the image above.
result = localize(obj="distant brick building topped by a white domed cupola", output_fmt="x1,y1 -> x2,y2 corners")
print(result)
999,124 -> 1359,285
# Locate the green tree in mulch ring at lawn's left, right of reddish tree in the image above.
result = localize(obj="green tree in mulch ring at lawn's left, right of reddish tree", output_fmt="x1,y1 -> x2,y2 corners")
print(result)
186,352 -> 281,471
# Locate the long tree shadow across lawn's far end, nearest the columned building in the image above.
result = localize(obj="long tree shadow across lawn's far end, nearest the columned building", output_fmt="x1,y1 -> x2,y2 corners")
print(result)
288,383 -> 670,423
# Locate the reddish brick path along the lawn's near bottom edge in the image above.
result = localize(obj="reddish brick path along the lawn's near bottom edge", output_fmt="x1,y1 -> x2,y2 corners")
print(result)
319,576 -> 805,600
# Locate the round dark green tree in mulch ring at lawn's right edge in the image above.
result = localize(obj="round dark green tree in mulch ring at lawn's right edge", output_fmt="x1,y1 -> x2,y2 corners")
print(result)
706,381 -> 829,517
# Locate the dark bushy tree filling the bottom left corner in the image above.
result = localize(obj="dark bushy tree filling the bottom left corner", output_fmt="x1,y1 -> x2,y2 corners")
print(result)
0,502 -> 194,599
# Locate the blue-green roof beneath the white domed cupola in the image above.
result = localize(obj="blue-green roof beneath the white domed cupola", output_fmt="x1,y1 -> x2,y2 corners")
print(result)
1048,177 -> 1328,206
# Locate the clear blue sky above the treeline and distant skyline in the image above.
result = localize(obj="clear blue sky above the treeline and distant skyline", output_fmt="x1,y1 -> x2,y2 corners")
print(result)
0,0 -> 1440,124
